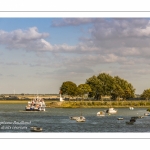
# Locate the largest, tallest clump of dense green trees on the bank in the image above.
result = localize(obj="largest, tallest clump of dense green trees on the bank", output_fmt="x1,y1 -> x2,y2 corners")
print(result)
86,73 -> 135,100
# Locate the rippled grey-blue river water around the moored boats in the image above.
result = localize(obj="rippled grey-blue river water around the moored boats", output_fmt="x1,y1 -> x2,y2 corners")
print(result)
0,104 -> 150,132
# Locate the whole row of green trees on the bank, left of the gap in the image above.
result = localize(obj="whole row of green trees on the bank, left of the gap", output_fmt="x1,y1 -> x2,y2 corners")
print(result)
60,73 -> 135,100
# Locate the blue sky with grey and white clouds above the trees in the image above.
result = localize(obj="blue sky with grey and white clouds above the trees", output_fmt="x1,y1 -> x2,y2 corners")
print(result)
0,17 -> 150,94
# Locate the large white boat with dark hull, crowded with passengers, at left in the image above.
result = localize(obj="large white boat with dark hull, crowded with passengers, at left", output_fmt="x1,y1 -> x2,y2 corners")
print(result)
25,96 -> 46,111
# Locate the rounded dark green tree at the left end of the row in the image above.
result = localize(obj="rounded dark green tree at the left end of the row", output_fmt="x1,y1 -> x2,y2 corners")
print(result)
60,81 -> 77,97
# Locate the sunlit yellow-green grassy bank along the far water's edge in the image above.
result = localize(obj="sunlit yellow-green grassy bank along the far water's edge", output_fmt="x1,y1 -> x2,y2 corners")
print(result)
0,100 -> 150,108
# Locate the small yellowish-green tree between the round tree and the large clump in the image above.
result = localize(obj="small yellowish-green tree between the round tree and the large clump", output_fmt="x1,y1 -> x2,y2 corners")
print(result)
77,84 -> 91,100
